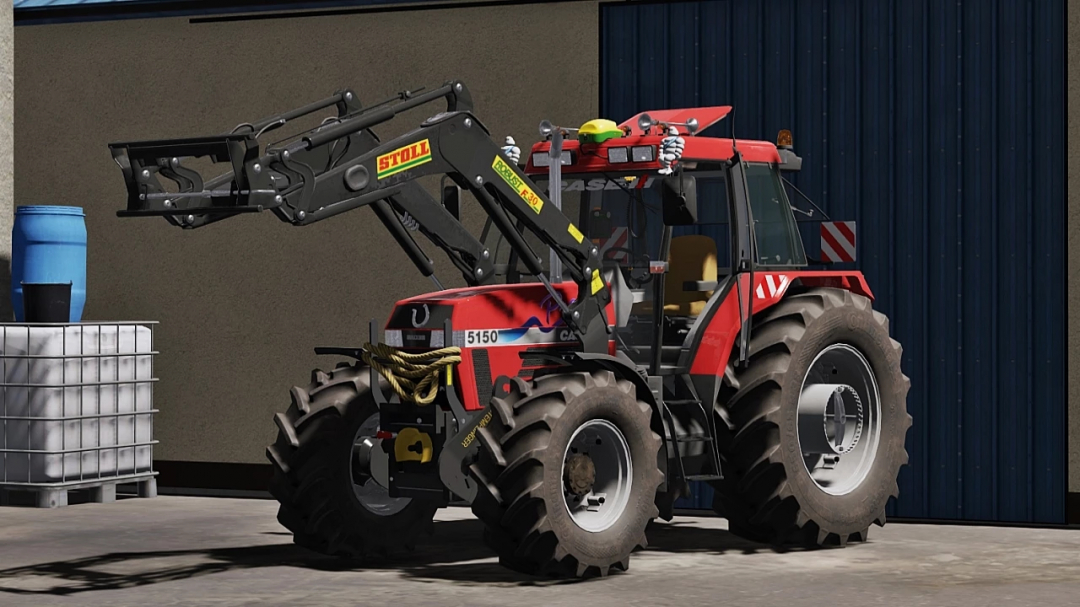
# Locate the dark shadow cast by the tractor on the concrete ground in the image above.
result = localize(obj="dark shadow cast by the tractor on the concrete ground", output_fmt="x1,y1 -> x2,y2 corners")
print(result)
0,511 -> 803,591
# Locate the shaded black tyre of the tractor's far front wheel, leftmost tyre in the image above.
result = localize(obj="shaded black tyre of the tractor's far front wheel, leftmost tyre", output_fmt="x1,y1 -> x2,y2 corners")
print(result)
267,364 -> 436,558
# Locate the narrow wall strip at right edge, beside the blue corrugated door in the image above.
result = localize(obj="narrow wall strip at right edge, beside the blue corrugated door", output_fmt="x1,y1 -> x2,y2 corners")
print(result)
1067,2 -> 1080,493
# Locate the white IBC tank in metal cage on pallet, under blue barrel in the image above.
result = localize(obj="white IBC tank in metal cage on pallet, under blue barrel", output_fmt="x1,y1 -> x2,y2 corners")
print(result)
0,321 -> 158,508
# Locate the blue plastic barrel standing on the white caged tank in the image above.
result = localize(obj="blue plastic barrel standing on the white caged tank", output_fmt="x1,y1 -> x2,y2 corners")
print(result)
11,205 -> 86,323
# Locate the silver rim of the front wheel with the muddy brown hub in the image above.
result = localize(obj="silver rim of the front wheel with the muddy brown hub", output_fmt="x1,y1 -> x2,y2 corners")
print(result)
559,419 -> 633,534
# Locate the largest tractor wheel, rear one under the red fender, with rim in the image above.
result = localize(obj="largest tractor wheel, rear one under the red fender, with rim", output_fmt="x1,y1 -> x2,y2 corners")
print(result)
713,288 -> 912,547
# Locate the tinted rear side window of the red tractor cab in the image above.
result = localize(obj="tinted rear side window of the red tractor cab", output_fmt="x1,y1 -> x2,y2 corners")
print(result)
746,164 -> 807,266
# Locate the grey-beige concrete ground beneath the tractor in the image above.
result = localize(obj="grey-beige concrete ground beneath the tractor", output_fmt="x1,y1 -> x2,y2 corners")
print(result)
0,497 -> 1080,607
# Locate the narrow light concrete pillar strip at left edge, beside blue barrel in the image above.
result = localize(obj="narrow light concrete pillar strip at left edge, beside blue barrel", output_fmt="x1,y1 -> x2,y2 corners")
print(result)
0,0 -> 15,322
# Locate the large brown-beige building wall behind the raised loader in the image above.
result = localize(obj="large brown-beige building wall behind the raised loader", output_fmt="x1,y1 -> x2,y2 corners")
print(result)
15,2 -> 598,462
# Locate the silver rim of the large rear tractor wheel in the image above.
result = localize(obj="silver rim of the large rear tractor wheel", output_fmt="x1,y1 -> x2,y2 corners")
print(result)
797,343 -> 881,496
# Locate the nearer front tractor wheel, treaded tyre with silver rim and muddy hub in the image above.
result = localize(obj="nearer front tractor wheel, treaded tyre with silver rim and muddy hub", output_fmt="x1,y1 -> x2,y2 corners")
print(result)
471,372 -> 662,577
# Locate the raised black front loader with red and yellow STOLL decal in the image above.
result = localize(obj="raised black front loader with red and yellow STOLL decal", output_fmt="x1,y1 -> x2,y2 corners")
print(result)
115,81 -> 611,353
